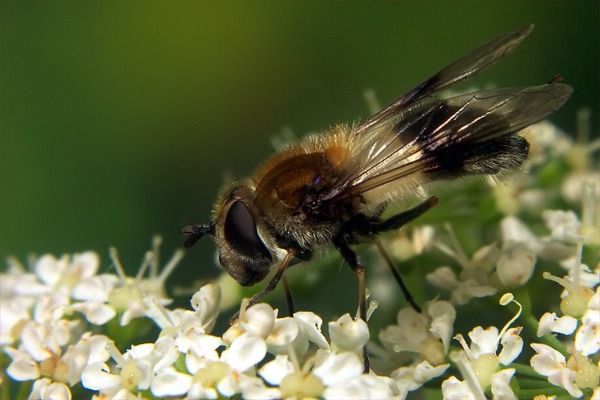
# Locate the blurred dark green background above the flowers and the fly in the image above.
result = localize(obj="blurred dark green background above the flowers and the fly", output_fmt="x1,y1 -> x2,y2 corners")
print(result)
0,0 -> 599,296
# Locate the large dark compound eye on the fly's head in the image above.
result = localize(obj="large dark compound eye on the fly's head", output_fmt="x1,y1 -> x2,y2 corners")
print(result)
224,200 -> 272,261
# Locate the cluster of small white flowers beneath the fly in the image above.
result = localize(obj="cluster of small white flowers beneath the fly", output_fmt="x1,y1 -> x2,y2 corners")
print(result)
0,116 -> 600,400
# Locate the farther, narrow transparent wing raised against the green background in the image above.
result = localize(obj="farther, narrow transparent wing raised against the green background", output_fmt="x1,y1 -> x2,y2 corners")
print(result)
358,25 -> 533,132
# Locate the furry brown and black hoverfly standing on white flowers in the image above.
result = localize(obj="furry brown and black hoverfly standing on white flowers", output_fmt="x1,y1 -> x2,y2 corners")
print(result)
183,26 -> 572,369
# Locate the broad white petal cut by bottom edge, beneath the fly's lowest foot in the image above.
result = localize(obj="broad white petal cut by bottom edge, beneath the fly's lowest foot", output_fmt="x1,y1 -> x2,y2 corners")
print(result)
323,375 -> 394,400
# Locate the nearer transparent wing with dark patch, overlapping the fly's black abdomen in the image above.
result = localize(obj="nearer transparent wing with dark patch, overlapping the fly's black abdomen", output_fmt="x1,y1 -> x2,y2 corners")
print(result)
322,83 -> 572,201
